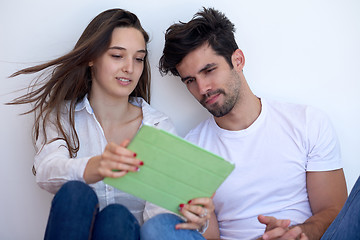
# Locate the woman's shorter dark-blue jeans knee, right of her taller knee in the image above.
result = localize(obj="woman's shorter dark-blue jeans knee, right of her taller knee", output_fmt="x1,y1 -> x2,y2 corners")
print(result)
92,204 -> 140,240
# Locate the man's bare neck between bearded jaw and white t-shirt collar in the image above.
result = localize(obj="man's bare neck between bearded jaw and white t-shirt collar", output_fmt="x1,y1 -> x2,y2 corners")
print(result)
214,93 -> 261,131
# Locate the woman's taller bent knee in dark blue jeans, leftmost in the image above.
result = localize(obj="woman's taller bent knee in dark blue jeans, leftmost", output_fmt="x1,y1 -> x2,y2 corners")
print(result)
44,181 -> 98,240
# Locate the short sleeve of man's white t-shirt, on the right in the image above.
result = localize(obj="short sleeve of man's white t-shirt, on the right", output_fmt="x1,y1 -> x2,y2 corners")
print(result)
306,107 -> 342,172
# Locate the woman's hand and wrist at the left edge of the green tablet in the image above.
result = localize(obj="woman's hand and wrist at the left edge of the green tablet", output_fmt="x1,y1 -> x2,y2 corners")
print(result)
84,140 -> 144,184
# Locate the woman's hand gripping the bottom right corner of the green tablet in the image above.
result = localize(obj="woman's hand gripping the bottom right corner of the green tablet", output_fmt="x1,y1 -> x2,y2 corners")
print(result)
175,198 -> 215,233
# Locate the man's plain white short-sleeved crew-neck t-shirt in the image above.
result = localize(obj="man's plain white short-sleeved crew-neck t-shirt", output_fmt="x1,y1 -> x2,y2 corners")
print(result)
185,99 -> 341,239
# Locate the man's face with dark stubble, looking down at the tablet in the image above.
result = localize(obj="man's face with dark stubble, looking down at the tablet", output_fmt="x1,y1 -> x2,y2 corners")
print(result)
176,44 -> 240,117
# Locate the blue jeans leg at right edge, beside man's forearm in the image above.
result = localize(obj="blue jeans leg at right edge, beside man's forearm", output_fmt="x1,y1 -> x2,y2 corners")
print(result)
321,177 -> 360,240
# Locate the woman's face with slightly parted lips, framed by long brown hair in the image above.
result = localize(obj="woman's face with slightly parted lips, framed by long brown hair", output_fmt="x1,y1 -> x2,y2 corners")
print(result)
89,27 -> 146,101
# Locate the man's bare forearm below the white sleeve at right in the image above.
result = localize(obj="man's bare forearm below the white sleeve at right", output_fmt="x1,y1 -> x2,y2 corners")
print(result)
299,169 -> 347,239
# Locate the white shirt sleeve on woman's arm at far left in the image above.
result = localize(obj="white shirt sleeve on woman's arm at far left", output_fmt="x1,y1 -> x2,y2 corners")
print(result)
34,113 -> 90,193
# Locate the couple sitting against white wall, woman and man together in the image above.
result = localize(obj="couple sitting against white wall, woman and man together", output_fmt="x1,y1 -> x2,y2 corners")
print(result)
10,8 -> 360,239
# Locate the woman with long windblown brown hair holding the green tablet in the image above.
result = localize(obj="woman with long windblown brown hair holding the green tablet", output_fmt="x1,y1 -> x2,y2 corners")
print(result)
11,9 -> 214,239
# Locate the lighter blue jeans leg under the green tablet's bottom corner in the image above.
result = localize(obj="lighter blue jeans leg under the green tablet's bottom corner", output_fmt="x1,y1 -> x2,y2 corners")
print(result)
140,213 -> 205,240
